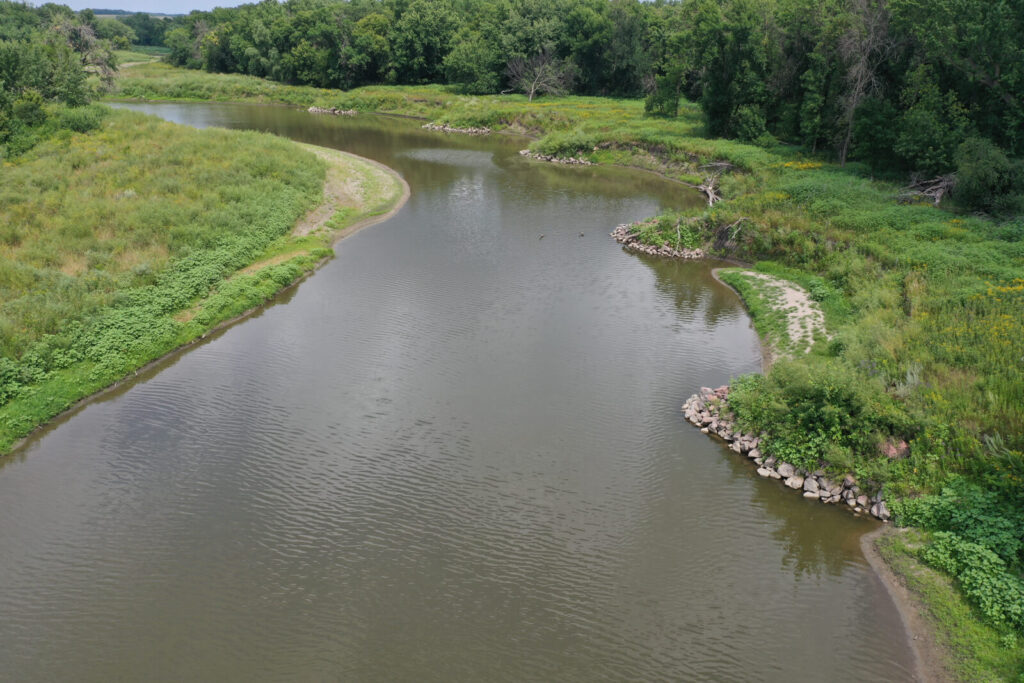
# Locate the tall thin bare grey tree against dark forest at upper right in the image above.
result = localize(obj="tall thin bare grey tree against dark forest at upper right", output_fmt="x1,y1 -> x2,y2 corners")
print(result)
839,0 -> 896,166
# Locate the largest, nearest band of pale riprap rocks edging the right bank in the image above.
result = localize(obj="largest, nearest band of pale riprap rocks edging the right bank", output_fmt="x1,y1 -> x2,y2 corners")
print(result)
683,386 -> 891,522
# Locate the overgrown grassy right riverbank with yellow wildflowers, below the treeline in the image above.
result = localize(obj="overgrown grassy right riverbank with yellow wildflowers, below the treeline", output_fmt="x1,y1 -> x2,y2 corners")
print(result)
108,65 -> 1024,680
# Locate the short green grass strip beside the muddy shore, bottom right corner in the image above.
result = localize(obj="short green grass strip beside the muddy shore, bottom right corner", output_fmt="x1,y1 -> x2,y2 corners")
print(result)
876,529 -> 1024,681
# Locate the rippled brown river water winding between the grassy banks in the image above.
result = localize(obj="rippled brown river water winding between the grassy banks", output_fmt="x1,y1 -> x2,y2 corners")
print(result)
0,103 -> 912,681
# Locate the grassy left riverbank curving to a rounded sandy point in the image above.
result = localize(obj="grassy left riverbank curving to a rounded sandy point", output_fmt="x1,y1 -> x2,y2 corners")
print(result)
0,112 -> 401,453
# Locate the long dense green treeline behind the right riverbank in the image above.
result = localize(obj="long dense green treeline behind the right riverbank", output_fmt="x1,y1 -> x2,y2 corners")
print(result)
153,0 -> 1024,212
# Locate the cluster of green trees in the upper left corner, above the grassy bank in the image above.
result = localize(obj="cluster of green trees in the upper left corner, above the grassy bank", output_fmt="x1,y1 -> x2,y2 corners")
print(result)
0,2 -> 115,157
